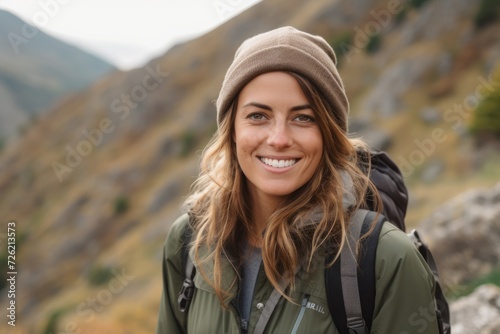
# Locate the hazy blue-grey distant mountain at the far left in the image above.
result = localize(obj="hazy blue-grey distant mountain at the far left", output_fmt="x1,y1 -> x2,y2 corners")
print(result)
0,10 -> 116,146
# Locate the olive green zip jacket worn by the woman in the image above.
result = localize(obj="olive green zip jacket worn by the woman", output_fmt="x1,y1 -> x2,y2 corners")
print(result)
156,215 -> 439,334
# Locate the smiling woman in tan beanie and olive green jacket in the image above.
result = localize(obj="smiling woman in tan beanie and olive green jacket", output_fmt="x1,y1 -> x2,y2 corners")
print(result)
157,27 -> 438,334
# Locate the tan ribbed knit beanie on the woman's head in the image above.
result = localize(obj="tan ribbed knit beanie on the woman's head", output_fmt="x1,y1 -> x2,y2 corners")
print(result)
217,27 -> 349,132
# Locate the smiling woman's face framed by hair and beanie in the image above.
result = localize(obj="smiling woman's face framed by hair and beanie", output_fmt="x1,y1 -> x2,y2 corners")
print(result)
234,72 -> 323,205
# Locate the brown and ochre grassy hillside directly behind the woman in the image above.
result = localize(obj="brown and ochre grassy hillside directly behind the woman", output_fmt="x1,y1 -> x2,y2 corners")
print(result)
0,0 -> 500,334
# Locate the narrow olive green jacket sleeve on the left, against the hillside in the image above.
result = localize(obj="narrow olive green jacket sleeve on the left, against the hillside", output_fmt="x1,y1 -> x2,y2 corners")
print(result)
156,215 -> 189,334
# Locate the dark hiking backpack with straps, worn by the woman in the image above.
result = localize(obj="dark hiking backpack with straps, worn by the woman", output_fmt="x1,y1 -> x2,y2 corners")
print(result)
178,150 -> 451,334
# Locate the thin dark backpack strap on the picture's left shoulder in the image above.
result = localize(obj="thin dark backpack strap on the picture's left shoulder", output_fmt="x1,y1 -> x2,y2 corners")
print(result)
177,225 -> 196,312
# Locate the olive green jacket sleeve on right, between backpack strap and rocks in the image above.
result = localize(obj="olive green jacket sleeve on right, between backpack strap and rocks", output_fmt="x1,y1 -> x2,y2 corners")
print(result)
371,223 -> 439,334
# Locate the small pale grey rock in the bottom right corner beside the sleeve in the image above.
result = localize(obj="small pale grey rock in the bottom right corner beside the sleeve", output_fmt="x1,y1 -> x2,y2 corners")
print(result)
450,284 -> 500,334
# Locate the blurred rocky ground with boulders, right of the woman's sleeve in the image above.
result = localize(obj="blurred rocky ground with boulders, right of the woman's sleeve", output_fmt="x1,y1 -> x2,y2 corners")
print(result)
419,183 -> 500,334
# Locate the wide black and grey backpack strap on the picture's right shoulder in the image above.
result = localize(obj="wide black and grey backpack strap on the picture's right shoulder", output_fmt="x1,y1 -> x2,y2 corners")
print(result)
325,210 -> 386,334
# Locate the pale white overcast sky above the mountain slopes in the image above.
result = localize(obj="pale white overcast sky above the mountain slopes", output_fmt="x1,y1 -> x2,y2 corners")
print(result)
0,0 -> 260,70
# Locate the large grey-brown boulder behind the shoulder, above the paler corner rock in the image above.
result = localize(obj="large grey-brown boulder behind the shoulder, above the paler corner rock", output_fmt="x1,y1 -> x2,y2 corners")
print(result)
419,183 -> 500,286
